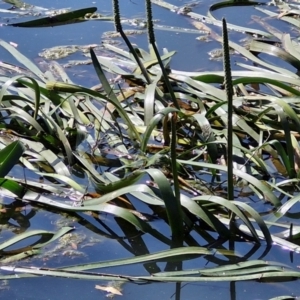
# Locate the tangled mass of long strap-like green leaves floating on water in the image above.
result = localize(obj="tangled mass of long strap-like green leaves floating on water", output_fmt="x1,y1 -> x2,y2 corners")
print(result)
0,0 -> 300,298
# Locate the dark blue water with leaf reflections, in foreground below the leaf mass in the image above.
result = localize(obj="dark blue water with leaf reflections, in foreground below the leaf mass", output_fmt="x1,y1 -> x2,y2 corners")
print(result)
0,195 -> 300,300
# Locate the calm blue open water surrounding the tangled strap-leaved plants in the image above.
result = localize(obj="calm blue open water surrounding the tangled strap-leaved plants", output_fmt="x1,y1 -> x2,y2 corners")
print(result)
0,0 -> 300,300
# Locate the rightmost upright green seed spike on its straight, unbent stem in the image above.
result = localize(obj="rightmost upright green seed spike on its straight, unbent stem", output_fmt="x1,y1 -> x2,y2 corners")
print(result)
222,18 -> 234,200
